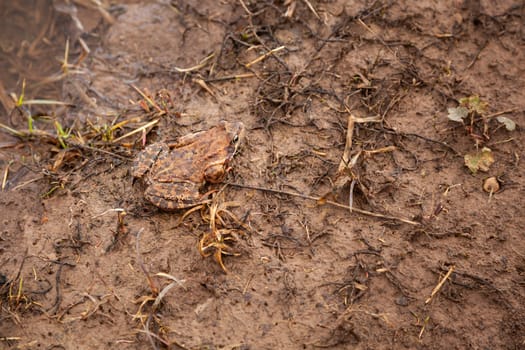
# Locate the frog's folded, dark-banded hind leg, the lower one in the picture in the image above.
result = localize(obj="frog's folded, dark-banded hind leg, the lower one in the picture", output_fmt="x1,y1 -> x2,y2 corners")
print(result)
144,181 -> 210,210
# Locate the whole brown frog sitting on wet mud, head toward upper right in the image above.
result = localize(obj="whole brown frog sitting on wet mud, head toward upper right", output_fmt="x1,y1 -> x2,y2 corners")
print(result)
131,121 -> 244,210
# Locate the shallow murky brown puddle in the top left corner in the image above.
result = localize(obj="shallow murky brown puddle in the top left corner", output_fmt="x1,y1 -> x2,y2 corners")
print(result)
0,0 -> 78,117
